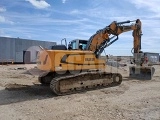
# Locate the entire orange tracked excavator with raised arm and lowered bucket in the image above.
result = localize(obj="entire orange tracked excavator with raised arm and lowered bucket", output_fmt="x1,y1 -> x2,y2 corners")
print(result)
37,19 -> 154,95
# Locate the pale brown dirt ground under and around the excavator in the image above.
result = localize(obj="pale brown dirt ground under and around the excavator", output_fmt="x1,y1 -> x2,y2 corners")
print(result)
0,65 -> 160,120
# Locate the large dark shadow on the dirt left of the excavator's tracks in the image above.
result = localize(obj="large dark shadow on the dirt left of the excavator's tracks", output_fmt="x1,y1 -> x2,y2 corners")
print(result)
0,85 -> 57,105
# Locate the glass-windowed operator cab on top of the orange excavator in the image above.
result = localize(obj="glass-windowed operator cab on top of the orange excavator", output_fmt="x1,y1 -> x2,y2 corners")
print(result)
68,39 -> 88,50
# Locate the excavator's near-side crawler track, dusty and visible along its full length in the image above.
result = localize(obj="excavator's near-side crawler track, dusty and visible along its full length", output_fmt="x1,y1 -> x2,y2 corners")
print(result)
50,72 -> 122,95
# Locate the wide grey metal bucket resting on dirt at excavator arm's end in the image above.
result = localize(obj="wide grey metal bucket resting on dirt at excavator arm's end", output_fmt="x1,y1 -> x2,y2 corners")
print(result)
129,66 -> 155,80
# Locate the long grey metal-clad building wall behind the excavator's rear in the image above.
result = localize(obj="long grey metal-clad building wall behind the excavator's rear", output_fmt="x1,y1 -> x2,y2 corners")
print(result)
0,37 -> 56,62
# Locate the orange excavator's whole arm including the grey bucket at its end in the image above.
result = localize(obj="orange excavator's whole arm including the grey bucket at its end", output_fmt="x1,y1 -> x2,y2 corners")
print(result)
86,19 -> 155,79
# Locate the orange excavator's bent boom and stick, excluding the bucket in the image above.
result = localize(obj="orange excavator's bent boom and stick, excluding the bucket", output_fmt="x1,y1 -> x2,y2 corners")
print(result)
86,19 -> 142,57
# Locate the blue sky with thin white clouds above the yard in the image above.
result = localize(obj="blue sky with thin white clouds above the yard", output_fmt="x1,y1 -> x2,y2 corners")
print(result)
0,0 -> 160,55
